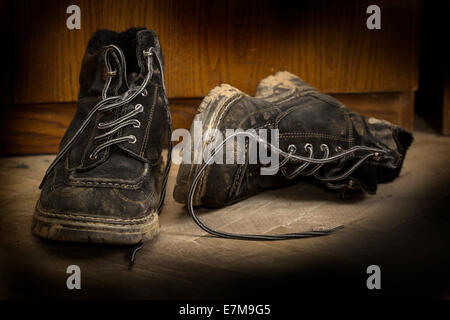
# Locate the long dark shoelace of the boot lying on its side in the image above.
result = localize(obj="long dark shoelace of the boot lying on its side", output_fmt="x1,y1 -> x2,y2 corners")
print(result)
187,131 -> 385,240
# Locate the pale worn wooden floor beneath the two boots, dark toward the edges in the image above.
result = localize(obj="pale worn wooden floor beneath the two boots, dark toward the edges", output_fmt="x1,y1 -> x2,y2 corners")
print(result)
0,119 -> 450,299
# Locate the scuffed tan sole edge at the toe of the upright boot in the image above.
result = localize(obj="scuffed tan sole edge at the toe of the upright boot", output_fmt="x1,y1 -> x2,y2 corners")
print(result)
31,201 -> 160,245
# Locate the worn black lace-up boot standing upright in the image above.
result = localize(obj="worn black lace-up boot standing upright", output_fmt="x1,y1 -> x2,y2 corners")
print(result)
32,28 -> 171,244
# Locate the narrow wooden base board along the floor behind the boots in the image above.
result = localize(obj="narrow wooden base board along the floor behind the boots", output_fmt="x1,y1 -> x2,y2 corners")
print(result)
0,92 -> 414,155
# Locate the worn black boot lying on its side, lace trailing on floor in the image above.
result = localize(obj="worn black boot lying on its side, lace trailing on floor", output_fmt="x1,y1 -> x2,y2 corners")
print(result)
174,72 -> 412,239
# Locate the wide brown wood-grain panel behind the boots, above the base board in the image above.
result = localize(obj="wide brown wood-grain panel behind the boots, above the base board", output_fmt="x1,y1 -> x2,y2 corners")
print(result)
14,0 -> 420,103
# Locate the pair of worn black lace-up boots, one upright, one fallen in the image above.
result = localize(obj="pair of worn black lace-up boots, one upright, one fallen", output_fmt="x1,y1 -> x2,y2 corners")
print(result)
32,28 -> 412,244
